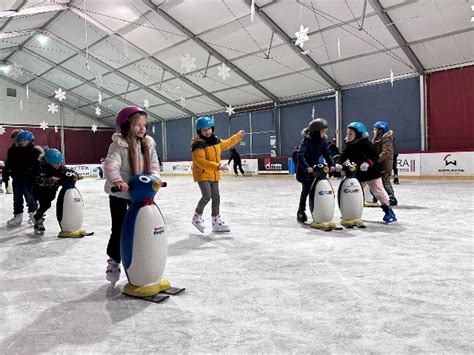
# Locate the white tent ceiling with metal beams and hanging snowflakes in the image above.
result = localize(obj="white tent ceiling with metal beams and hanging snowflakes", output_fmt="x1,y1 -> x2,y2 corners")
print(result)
0,0 -> 474,125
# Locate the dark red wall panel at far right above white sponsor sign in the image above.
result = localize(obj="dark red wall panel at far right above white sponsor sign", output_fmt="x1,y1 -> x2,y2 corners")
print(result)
427,66 -> 474,151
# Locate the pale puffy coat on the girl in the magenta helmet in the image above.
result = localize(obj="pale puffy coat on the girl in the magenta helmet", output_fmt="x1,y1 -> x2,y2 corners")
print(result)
104,133 -> 160,199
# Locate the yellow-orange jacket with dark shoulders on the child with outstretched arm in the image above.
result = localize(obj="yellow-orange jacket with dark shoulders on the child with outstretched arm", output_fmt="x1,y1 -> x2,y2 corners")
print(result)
191,133 -> 242,181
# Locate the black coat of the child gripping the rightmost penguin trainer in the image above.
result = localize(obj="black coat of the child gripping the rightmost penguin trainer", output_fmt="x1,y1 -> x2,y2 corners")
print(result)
338,137 -> 382,182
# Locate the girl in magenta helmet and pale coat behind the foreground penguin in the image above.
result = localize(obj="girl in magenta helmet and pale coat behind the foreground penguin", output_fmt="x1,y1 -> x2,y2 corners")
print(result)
104,106 -> 160,286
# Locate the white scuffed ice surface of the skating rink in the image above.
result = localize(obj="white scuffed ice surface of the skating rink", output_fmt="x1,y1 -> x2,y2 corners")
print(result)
0,176 -> 474,354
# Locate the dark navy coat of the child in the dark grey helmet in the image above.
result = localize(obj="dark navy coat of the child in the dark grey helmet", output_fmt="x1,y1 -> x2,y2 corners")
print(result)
296,128 -> 334,183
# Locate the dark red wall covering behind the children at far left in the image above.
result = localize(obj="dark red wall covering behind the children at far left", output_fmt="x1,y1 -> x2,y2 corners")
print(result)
0,127 -> 114,164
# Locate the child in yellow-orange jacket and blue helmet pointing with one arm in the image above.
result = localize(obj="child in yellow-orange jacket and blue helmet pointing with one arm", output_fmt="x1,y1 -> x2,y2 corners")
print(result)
191,117 -> 245,233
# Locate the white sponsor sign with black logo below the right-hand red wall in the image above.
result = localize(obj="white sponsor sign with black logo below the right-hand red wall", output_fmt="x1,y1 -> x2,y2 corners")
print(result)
421,152 -> 474,176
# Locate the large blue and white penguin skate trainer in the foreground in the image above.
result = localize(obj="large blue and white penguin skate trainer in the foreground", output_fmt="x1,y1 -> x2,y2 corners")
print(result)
120,175 -> 184,302
